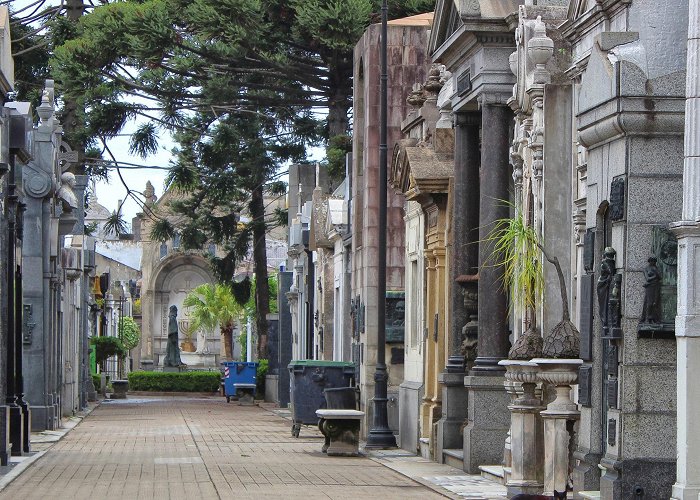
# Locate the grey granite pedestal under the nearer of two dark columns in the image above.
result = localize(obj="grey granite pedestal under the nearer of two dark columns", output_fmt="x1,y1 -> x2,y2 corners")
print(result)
463,375 -> 510,474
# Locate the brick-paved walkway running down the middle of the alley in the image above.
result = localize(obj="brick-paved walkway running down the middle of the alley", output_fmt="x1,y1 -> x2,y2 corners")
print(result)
0,396 -> 444,500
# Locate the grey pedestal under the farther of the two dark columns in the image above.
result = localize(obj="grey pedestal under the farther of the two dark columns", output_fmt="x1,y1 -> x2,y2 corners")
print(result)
435,373 -> 468,464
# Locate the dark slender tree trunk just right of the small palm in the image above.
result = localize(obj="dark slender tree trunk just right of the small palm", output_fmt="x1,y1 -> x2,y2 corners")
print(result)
250,183 -> 270,359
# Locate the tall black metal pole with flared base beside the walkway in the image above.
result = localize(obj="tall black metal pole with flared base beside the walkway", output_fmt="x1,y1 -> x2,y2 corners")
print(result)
367,0 -> 396,448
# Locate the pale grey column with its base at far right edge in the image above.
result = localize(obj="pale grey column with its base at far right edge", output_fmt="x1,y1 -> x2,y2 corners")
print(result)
671,5 -> 700,500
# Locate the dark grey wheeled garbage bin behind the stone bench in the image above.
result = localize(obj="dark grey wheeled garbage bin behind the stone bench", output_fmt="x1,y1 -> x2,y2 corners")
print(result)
288,359 -> 355,437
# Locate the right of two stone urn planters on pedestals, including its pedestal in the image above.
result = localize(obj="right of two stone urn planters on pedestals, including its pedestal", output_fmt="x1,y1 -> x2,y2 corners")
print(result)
532,358 -> 583,492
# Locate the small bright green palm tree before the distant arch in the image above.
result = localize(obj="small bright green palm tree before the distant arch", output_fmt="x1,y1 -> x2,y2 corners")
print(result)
183,283 -> 245,359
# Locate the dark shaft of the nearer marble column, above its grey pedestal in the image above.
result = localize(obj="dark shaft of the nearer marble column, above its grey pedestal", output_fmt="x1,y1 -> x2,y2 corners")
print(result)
472,104 -> 513,375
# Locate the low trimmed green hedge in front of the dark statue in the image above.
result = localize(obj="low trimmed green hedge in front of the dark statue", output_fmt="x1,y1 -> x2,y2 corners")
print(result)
129,371 -> 221,392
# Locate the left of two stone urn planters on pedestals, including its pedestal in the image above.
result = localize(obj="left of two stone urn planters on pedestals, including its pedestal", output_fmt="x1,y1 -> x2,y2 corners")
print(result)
498,360 -> 544,497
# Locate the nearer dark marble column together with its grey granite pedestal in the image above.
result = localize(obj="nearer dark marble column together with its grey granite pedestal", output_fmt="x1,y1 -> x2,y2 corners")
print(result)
463,100 -> 512,474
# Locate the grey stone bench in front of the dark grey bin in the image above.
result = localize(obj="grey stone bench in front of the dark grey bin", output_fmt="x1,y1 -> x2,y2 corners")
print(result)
316,410 -> 365,457
